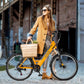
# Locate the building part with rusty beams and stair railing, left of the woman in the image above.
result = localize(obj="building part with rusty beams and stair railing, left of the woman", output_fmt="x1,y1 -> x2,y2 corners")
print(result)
0,0 -> 55,57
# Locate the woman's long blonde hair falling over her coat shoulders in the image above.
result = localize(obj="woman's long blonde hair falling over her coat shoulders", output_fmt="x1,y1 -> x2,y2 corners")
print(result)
42,4 -> 52,28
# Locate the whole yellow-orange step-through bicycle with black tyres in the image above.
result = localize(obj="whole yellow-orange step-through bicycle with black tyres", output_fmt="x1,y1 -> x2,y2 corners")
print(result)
6,33 -> 78,81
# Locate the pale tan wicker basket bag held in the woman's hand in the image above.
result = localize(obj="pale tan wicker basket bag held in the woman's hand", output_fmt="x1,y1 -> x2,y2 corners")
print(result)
20,41 -> 38,57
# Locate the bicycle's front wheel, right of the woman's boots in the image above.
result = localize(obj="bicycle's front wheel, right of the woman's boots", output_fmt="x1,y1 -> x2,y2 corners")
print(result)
50,54 -> 78,80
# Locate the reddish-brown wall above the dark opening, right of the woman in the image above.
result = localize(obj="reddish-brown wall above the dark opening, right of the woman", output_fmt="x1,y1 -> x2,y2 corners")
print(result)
56,0 -> 76,30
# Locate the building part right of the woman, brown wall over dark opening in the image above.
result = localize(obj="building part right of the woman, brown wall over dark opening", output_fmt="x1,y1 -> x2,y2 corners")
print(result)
56,0 -> 77,58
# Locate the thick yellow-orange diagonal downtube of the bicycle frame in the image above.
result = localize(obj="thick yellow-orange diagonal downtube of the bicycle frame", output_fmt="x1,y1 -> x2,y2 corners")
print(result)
37,41 -> 57,67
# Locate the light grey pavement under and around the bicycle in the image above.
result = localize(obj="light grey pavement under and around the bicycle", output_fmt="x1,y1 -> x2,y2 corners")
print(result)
0,58 -> 84,84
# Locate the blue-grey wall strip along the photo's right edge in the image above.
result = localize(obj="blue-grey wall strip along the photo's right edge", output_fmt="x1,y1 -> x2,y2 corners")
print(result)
77,0 -> 84,62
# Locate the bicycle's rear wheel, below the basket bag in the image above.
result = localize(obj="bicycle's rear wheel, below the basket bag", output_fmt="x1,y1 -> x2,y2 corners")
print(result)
6,54 -> 33,81
